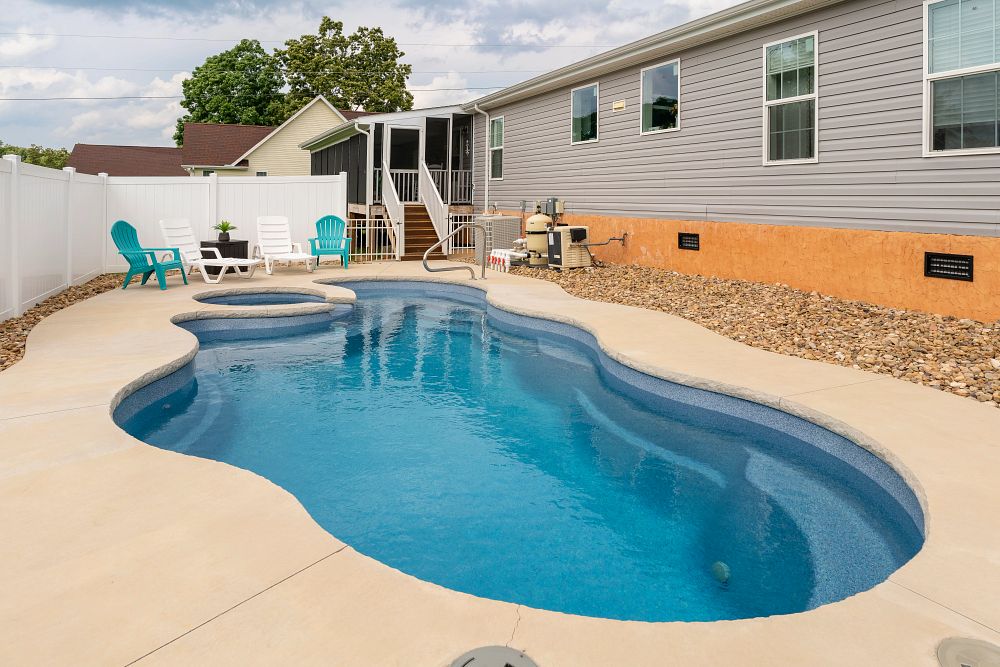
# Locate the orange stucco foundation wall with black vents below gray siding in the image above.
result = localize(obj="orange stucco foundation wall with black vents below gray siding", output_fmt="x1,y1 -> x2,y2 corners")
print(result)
548,214 -> 1000,322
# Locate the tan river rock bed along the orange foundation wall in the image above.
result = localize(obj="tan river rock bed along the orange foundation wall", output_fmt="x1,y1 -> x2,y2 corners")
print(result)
511,265 -> 1000,407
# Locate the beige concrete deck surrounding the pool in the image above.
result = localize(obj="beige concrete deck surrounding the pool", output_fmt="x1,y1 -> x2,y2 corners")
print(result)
0,263 -> 1000,667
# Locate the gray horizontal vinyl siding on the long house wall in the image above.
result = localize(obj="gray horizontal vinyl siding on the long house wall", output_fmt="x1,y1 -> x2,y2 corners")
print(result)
474,0 -> 1000,236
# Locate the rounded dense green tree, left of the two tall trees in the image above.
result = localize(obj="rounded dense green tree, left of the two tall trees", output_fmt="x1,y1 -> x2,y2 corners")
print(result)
174,39 -> 286,146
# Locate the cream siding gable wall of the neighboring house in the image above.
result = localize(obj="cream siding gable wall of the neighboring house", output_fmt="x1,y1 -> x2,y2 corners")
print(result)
244,102 -> 344,176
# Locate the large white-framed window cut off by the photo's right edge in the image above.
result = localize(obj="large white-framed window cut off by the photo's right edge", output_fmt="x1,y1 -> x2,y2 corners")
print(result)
924,0 -> 1000,155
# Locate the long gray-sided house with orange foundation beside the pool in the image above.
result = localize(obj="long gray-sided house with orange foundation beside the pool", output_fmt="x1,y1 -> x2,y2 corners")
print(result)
463,0 -> 1000,320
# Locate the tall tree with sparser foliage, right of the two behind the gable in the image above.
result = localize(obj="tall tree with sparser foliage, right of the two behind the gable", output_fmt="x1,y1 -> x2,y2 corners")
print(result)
274,16 -> 413,115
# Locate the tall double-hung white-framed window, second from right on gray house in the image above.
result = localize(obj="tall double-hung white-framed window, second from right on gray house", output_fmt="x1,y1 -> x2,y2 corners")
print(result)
764,33 -> 818,164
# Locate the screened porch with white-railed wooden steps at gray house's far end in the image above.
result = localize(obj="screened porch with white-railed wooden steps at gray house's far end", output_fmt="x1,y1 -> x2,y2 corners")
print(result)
300,106 -> 472,259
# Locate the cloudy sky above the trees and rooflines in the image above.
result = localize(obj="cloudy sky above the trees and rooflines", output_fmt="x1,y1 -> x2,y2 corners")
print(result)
0,0 -> 736,148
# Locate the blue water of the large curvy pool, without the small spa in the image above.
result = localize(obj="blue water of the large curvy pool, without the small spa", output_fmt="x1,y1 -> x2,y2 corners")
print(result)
116,283 -> 923,621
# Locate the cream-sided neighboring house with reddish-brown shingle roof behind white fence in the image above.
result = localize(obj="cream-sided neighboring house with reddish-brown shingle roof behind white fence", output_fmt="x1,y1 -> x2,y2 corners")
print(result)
183,95 -> 364,176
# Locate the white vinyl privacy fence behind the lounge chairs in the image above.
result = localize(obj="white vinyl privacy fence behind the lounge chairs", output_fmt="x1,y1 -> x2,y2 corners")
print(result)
0,156 -> 347,320
